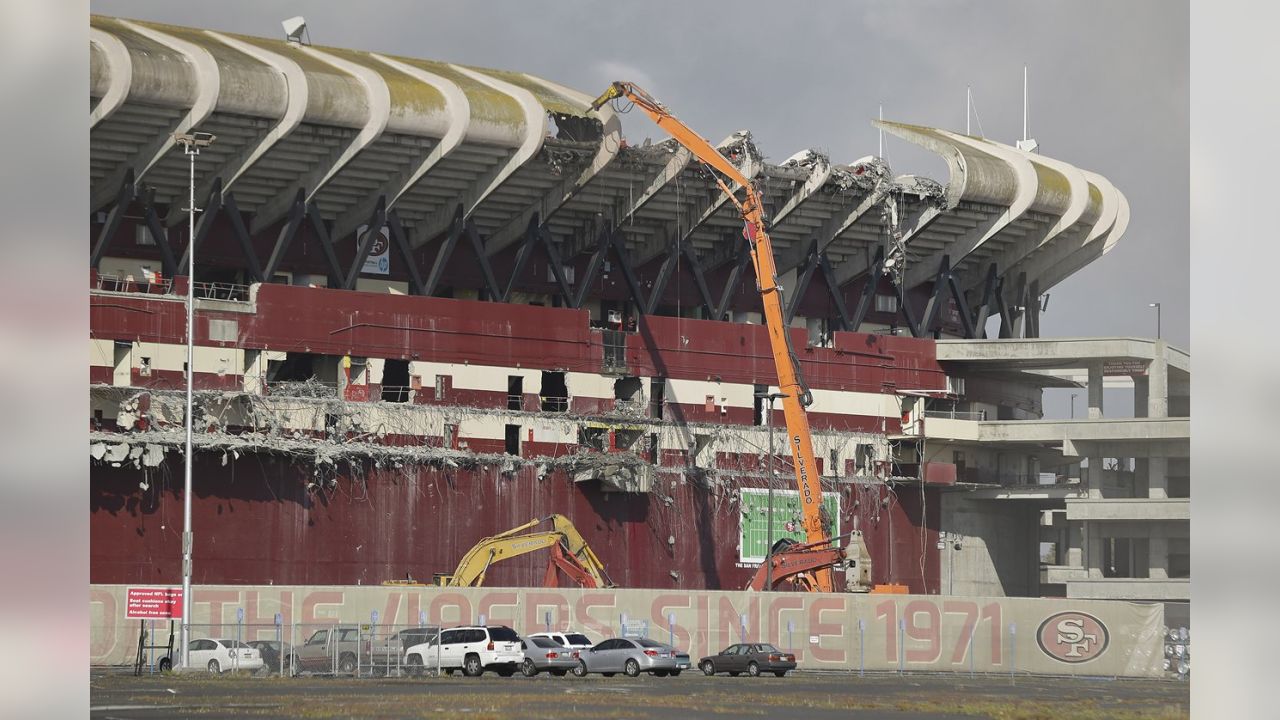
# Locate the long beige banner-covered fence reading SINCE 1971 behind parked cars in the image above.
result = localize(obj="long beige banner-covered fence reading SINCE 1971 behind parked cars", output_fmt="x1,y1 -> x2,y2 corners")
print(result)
90,585 -> 1164,676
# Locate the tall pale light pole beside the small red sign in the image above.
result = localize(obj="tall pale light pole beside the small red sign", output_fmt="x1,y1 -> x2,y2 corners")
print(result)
173,132 -> 216,667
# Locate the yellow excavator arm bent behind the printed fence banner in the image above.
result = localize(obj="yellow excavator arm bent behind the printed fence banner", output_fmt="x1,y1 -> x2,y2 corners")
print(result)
433,515 -> 614,588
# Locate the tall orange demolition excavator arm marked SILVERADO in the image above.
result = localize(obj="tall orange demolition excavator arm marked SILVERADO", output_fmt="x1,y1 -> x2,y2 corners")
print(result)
591,82 -> 832,592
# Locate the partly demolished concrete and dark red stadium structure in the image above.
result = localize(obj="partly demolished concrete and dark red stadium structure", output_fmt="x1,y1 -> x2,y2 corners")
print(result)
88,17 -> 1190,601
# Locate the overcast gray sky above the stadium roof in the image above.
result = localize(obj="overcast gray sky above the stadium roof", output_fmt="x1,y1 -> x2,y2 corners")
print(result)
92,0 -> 1189,348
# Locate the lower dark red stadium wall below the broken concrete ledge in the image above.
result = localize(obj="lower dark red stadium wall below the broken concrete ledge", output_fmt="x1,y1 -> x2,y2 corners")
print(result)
90,455 -> 941,593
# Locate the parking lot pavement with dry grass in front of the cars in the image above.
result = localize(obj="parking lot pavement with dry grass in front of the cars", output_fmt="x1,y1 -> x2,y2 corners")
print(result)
90,671 -> 1189,720
